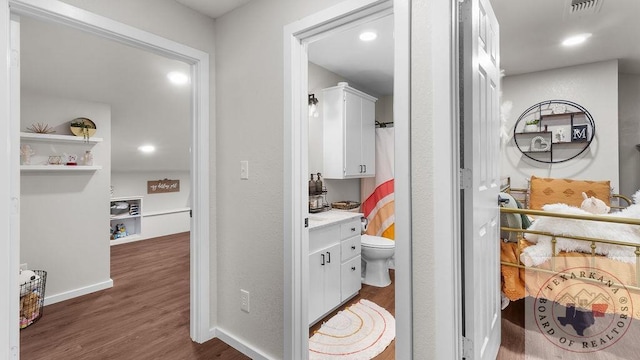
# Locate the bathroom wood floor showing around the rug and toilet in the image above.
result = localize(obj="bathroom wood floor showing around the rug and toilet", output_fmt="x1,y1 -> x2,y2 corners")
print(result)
309,270 -> 396,360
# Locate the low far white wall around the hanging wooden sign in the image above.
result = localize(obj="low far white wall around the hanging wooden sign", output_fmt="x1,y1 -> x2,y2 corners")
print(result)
111,171 -> 191,239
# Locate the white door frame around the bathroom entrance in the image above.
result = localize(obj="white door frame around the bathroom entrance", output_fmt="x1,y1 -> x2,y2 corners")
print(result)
284,0 -> 413,359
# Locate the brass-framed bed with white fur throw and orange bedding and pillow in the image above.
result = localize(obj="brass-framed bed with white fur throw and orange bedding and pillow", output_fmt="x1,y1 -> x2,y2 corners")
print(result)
500,177 -> 640,318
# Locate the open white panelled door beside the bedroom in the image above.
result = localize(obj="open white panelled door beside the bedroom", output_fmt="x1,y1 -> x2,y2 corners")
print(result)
460,0 -> 501,360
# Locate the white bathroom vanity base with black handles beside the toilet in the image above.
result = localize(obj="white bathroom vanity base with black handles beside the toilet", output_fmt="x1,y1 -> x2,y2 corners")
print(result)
308,210 -> 362,325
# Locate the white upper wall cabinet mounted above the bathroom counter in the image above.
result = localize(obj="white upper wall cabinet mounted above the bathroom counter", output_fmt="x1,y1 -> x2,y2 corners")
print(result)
322,83 -> 378,179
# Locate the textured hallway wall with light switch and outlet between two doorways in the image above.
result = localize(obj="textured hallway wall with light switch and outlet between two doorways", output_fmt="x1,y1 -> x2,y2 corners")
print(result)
216,0 -> 376,359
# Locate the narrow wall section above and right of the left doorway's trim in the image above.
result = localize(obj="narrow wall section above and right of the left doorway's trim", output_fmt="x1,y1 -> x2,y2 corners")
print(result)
63,0 -> 218,326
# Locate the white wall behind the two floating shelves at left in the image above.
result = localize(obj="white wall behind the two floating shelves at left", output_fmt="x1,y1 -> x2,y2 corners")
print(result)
20,89 -> 111,303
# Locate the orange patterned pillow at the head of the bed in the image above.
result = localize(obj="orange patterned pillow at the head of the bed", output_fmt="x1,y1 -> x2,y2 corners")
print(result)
529,176 -> 611,210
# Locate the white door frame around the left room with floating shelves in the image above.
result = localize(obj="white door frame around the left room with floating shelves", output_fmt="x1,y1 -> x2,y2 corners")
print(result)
0,0 -> 214,359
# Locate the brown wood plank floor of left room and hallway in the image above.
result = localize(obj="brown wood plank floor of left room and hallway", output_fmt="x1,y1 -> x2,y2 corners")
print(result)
20,233 -> 249,360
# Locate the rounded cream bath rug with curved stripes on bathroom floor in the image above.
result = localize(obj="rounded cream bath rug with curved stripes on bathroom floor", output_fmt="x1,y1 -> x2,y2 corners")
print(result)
309,299 -> 396,360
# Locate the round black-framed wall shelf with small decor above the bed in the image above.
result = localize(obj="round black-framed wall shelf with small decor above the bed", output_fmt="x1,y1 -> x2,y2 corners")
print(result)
513,100 -> 596,164
